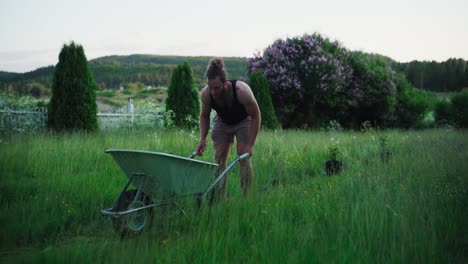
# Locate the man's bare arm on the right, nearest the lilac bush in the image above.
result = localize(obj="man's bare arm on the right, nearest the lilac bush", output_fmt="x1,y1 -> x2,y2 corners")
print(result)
237,81 -> 262,154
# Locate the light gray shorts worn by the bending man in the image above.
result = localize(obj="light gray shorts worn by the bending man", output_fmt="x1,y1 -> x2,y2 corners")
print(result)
211,115 -> 252,145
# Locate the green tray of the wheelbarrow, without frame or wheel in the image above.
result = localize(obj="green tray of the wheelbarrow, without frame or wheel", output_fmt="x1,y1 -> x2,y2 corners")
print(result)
106,149 -> 218,198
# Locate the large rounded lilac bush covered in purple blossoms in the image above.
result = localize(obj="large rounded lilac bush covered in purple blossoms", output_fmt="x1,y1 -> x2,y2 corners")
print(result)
248,34 -> 351,127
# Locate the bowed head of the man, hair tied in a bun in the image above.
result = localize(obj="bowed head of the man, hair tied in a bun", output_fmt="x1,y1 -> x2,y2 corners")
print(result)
205,58 -> 227,98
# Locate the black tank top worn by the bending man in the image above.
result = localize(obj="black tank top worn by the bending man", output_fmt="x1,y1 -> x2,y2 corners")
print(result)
210,80 -> 249,125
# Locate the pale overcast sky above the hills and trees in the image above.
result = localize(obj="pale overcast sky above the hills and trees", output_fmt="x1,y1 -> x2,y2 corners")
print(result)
0,0 -> 468,72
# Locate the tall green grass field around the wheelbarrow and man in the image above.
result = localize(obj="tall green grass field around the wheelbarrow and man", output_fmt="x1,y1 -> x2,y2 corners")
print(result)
0,129 -> 468,263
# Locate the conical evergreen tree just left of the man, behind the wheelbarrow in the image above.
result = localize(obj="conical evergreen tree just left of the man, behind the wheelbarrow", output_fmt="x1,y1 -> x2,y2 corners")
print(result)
166,61 -> 200,127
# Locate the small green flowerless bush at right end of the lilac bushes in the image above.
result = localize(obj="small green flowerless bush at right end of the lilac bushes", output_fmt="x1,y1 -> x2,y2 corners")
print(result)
395,74 -> 429,128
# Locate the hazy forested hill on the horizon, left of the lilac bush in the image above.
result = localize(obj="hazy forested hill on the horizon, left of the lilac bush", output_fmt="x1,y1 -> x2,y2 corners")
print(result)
0,55 -> 247,92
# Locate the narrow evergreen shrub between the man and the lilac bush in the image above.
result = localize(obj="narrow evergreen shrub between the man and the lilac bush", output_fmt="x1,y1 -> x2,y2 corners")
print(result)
249,71 -> 278,129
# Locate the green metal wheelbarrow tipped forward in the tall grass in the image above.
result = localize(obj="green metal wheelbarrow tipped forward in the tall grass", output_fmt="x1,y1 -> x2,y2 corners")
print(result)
101,149 -> 250,237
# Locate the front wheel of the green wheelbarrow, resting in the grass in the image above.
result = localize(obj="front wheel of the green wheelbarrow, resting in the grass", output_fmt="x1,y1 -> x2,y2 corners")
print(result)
112,190 -> 153,238
